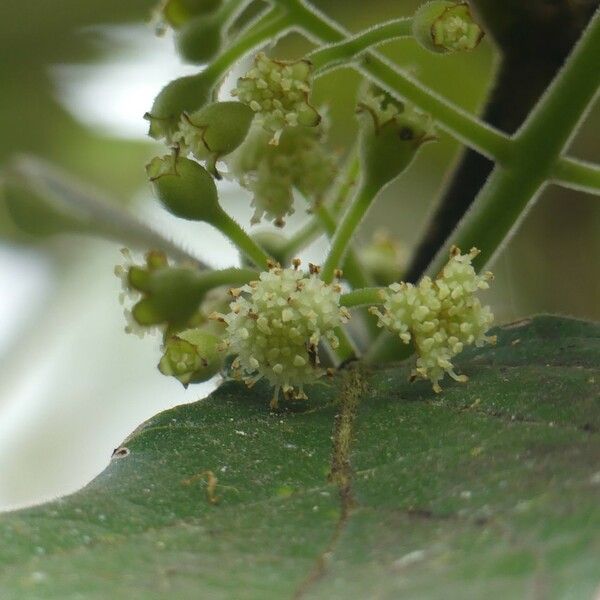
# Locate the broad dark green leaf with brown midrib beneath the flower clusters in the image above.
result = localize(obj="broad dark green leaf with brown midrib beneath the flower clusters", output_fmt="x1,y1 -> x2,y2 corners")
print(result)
0,317 -> 600,600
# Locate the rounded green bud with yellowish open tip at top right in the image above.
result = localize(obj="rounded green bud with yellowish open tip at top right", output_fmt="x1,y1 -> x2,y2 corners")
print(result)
413,0 -> 484,53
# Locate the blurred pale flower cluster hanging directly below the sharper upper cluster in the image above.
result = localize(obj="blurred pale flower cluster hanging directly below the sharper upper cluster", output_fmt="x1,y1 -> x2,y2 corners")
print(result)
226,126 -> 337,227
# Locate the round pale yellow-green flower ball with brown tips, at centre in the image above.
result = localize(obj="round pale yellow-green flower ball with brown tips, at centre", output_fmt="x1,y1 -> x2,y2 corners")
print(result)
214,261 -> 349,407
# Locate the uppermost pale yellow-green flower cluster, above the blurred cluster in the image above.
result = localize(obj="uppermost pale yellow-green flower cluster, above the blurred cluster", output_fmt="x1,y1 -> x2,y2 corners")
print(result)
231,52 -> 321,144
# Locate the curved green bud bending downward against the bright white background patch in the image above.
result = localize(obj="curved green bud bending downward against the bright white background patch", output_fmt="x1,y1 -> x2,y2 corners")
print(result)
144,72 -> 214,142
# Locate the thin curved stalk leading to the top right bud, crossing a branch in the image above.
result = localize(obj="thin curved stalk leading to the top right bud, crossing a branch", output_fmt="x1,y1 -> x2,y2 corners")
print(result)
307,18 -> 412,73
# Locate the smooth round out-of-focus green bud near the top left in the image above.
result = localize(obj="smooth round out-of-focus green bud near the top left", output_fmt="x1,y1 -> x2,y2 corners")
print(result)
175,14 -> 223,64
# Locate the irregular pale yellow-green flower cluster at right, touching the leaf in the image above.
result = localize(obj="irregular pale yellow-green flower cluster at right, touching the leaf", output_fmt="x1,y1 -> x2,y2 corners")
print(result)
371,248 -> 495,392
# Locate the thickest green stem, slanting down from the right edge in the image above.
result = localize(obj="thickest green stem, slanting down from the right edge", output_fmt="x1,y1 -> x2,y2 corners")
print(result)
427,9 -> 600,276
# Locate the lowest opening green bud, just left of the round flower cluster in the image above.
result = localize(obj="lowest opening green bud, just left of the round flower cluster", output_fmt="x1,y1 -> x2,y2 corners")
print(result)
158,329 -> 224,387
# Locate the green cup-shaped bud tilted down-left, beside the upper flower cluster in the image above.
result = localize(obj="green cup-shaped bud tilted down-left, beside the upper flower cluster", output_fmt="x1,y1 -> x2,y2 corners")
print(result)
176,102 -> 254,178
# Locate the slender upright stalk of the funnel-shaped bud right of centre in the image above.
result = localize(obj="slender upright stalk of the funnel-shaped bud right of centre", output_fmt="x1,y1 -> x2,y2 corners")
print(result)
321,182 -> 379,283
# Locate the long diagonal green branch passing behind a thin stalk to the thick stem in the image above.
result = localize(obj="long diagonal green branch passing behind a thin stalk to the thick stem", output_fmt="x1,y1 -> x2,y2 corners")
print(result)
285,0 -> 511,161
